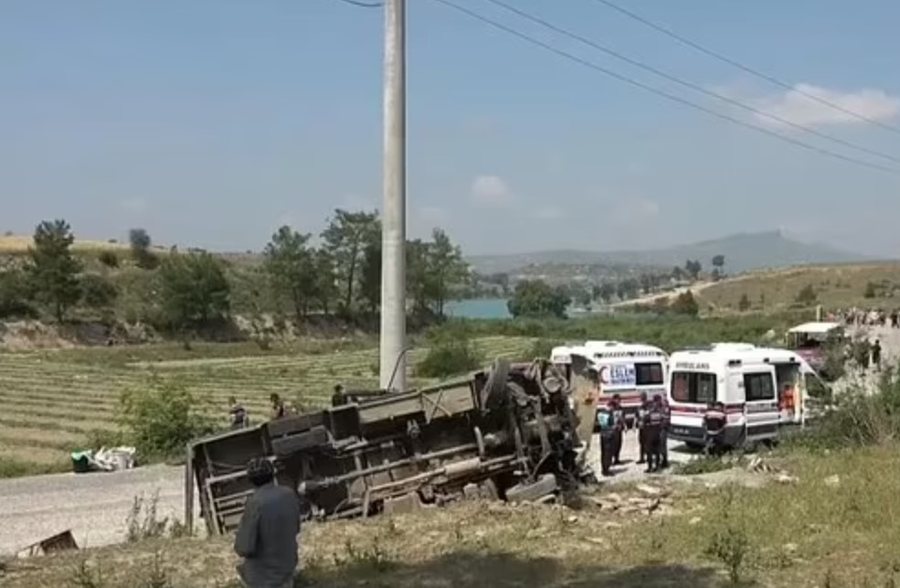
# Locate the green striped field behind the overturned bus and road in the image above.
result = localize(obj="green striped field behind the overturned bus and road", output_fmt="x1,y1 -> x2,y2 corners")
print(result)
0,337 -> 532,470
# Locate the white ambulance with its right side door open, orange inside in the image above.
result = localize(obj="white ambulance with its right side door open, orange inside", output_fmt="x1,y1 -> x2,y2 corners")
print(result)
668,343 -> 818,447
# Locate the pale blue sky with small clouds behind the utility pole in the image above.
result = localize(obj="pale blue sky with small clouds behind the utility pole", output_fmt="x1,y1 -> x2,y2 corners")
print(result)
0,0 -> 900,257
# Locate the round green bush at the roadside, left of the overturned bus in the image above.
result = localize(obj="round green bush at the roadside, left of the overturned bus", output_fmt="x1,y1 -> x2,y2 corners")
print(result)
121,381 -> 214,460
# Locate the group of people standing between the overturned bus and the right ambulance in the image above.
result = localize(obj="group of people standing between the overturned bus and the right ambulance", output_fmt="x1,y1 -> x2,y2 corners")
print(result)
597,393 -> 670,476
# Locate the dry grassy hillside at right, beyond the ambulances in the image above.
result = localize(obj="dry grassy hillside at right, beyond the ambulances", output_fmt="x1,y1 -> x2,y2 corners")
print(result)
698,262 -> 900,313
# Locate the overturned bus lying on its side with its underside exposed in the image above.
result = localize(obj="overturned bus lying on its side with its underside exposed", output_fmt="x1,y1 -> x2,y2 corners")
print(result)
185,360 -> 593,534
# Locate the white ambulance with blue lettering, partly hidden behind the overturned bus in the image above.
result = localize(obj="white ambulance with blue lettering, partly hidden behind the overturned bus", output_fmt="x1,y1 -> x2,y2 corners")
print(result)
552,341 -> 668,420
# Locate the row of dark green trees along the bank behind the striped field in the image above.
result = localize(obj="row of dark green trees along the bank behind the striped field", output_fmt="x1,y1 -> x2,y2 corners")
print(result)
0,209 -> 469,330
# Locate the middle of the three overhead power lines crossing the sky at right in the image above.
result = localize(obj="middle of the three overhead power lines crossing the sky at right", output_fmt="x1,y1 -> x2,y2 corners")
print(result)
487,0 -> 900,171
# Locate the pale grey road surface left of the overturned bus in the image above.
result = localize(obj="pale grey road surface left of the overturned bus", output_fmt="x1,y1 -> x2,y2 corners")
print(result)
0,466 -> 190,554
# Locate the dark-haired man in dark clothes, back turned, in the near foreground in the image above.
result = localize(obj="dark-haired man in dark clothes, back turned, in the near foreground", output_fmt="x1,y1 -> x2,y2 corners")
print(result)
234,458 -> 300,588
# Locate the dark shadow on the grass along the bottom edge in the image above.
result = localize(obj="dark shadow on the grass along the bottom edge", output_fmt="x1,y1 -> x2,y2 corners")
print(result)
299,546 -> 740,588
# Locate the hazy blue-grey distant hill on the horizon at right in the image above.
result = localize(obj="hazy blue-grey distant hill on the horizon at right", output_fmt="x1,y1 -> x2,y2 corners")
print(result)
468,231 -> 870,274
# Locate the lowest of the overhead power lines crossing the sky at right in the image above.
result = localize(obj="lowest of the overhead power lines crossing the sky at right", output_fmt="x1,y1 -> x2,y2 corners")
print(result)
435,0 -> 900,175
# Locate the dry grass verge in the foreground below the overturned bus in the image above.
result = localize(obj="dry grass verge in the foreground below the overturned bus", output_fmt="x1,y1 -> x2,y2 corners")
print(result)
4,447 -> 900,588
